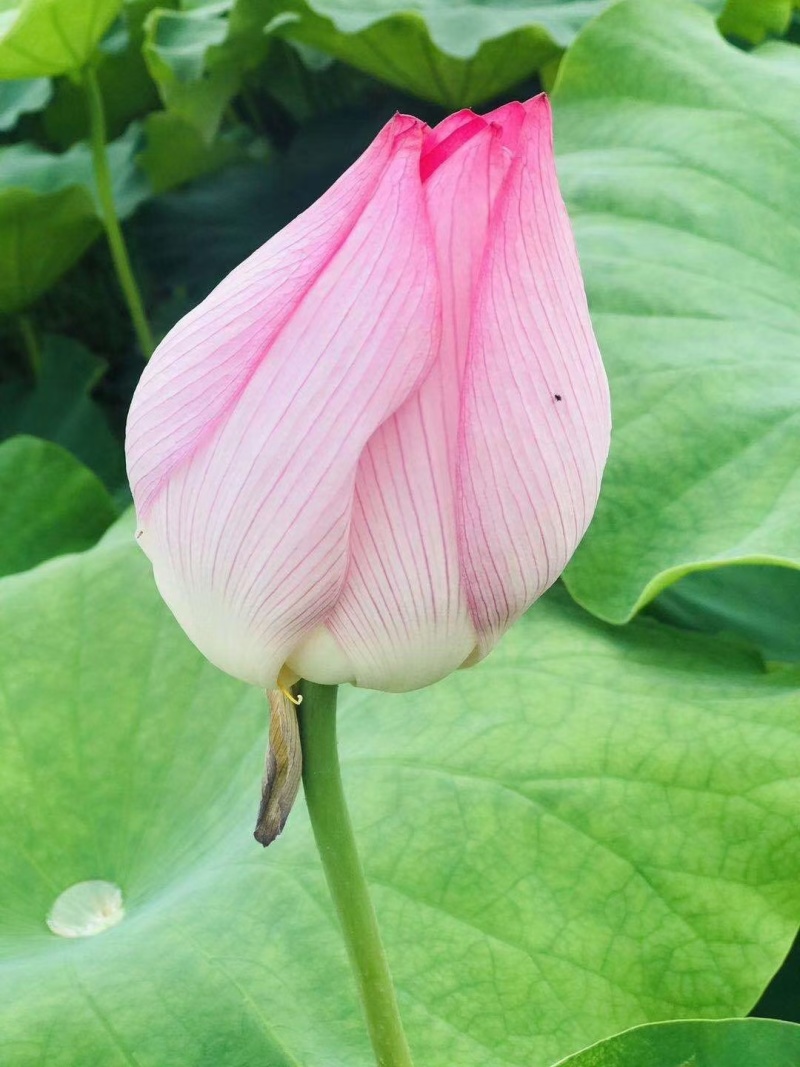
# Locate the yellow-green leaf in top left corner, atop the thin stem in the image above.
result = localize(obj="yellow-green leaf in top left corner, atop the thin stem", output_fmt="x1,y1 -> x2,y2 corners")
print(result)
0,0 -> 123,79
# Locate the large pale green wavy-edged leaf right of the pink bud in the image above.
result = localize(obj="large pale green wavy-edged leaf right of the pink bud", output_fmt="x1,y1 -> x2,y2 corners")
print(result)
555,0 -> 800,622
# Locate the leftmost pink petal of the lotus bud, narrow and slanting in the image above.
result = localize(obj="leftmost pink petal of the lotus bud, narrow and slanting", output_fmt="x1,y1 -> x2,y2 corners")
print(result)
126,115 -> 421,519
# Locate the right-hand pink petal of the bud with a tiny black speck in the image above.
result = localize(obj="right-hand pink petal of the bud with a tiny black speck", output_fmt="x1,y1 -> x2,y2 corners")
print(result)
459,97 -> 610,654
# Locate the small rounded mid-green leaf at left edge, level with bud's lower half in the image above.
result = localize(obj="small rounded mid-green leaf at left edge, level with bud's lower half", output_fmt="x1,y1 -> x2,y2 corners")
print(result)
0,436 -> 116,576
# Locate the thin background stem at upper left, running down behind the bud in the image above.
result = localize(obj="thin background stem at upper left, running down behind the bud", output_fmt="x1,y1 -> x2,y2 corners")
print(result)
83,65 -> 156,359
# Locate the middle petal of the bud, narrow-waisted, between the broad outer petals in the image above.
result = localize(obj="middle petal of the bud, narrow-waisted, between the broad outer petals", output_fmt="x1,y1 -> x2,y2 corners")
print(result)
327,124 -> 505,690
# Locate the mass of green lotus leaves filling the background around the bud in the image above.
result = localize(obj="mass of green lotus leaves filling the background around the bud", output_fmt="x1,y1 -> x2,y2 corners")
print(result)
0,0 -> 800,1067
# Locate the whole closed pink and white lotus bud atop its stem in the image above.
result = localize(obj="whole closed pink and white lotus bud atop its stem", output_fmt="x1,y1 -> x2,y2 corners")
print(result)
127,96 -> 610,691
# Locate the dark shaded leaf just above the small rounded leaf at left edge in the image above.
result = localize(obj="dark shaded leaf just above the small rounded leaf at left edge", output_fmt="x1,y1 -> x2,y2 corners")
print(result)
0,336 -> 125,490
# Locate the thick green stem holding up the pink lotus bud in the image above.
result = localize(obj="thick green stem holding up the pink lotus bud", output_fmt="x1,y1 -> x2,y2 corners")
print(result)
298,682 -> 413,1067
